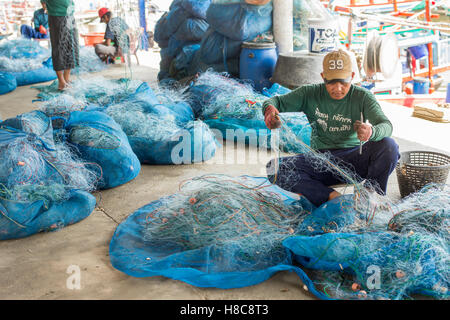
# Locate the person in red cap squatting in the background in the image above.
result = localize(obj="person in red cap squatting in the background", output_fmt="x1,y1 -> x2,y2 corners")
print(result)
95,8 -> 130,63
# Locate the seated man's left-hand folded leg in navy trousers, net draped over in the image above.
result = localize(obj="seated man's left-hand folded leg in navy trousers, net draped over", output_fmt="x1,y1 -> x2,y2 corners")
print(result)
266,154 -> 341,206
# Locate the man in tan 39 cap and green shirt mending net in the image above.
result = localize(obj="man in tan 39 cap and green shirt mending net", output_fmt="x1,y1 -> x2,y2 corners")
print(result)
262,50 -> 400,206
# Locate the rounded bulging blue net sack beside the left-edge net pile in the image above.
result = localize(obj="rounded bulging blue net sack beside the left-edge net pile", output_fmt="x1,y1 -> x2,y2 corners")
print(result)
60,111 -> 141,189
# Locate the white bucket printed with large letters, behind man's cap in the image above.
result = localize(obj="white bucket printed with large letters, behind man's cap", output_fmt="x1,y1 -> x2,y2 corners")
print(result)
308,18 -> 337,53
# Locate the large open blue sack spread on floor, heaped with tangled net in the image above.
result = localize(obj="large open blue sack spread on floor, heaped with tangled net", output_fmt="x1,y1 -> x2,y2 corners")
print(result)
109,174 -> 326,298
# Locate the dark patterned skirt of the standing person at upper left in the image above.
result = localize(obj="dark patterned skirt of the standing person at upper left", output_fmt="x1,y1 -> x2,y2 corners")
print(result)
48,16 -> 79,71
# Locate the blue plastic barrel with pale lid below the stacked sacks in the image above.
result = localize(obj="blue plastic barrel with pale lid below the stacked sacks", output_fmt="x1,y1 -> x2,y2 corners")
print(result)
239,42 -> 278,91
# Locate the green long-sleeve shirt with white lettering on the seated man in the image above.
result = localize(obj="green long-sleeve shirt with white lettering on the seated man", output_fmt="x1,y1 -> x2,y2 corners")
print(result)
262,83 -> 392,149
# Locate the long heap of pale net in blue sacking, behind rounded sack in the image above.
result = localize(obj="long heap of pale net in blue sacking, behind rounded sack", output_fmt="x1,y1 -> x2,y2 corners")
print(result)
33,77 -> 218,165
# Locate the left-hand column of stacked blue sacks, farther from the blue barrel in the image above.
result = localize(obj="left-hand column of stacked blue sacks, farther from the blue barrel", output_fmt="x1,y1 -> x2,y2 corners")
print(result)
154,0 -> 211,80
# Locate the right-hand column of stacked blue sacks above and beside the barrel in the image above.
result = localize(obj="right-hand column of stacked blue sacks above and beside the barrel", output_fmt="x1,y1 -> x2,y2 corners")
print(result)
188,0 -> 272,76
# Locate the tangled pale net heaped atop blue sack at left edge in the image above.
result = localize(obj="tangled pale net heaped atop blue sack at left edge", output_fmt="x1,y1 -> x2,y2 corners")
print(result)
0,112 -> 97,202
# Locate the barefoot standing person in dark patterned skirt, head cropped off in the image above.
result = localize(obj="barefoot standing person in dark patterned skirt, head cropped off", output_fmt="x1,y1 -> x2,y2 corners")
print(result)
44,0 -> 79,90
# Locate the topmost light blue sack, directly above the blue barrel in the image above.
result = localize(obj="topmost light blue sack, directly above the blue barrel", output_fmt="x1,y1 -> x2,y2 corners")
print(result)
206,2 -> 272,41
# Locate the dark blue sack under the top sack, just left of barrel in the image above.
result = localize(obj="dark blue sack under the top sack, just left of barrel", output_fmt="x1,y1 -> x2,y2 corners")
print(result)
200,27 -> 242,64
